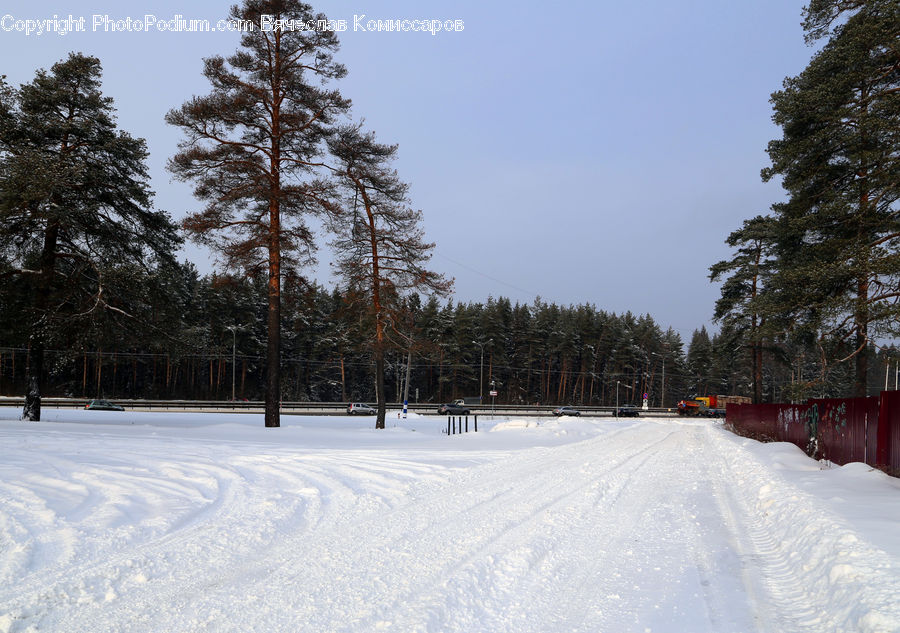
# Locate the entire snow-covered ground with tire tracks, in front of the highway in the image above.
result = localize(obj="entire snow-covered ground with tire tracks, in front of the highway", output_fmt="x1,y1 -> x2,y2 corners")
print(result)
0,409 -> 900,633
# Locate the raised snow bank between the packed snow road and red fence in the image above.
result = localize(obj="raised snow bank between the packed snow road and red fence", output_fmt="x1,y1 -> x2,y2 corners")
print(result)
718,432 -> 900,633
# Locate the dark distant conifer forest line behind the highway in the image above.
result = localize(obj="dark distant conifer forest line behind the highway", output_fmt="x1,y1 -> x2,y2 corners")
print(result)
0,264 -> 900,408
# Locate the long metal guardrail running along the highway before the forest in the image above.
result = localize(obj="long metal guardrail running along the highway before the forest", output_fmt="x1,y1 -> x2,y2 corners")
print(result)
0,396 -> 677,417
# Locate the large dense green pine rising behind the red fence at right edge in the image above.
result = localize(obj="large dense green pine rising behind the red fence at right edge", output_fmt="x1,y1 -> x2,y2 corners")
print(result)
763,0 -> 900,396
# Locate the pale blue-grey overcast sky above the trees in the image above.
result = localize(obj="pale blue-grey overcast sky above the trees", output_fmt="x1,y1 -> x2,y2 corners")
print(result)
0,0 -> 813,342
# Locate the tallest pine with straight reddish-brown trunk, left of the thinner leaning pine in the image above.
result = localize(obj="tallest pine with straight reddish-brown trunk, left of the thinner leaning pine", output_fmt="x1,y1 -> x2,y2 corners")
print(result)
166,0 -> 350,427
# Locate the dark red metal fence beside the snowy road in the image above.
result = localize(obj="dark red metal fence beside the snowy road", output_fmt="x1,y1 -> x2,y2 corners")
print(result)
726,391 -> 900,475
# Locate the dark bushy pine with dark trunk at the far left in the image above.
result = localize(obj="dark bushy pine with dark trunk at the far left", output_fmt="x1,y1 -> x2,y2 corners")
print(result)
0,53 -> 179,420
